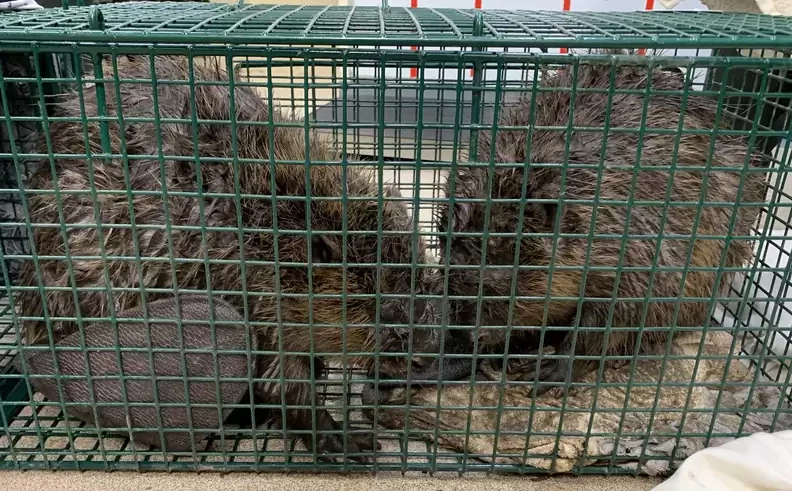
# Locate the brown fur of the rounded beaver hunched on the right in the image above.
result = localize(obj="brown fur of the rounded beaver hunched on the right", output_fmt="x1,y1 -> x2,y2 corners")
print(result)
439,57 -> 765,391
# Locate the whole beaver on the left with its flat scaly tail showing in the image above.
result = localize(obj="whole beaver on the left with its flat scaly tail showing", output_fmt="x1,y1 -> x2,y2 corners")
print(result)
4,55 -> 446,459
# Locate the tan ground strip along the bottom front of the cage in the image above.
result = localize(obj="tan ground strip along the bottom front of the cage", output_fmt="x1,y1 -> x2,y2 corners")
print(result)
0,471 -> 661,491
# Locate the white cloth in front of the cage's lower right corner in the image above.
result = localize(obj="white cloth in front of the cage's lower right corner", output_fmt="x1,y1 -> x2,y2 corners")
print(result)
652,431 -> 792,491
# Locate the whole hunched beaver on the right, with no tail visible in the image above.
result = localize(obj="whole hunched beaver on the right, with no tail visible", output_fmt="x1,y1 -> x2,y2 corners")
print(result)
369,59 -> 766,398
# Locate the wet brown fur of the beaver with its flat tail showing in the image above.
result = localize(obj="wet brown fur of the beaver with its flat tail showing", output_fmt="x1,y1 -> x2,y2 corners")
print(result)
17,56 -> 439,462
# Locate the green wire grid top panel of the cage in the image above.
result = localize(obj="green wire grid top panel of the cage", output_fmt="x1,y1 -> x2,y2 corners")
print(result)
0,0 -> 792,48
